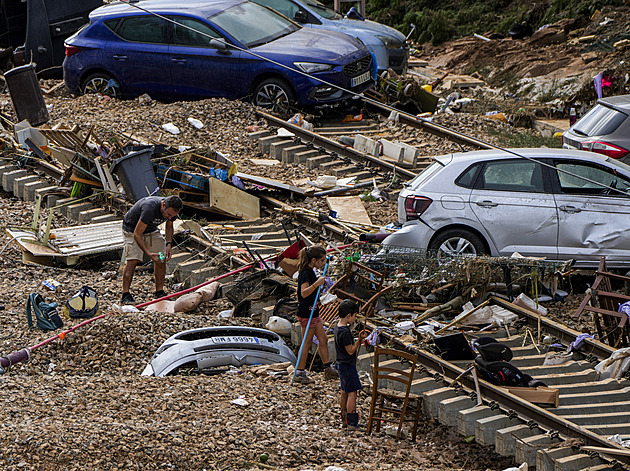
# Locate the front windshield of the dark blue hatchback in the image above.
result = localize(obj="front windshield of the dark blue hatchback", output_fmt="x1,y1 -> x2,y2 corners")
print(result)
208,2 -> 300,47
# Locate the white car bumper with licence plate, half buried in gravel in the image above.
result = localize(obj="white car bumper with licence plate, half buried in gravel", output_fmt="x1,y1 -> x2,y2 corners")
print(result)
142,326 -> 296,376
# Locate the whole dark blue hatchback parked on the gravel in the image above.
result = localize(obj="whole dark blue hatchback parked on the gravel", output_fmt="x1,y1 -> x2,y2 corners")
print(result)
63,0 -> 375,114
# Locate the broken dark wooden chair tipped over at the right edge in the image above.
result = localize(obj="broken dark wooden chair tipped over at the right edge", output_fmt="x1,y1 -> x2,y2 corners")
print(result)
573,257 -> 630,348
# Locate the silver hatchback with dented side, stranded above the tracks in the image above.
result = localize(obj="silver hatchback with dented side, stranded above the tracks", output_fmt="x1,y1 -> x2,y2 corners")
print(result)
383,148 -> 630,268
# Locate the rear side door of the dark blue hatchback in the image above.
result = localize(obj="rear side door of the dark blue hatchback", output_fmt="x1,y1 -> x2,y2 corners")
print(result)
102,15 -> 171,96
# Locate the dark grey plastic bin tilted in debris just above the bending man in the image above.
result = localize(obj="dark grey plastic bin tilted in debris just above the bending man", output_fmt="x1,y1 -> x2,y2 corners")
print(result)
111,147 -> 158,202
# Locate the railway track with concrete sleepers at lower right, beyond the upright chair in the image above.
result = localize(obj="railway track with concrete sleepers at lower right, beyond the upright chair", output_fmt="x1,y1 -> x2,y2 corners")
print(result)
360,298 -> 630,471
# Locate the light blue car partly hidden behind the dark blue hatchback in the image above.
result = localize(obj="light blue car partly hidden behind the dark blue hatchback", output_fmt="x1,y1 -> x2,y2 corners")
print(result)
252,0 -> 409,74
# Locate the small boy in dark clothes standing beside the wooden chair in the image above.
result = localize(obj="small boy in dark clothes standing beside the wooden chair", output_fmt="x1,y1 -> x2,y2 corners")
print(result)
335,299 -> 368,430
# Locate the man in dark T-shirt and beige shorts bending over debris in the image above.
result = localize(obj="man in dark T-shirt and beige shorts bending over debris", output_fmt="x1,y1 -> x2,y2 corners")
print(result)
121,195 -> 183,304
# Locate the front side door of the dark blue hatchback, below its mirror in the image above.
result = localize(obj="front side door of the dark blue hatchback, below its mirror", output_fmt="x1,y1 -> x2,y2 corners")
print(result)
170,16 -> 248,98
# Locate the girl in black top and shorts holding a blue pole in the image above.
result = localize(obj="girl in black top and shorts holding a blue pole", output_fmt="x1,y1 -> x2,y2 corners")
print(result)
294,245 -> 337,384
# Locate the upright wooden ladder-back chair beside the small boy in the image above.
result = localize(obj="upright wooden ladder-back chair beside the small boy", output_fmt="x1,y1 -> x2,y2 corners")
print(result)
367,346 -> 422,441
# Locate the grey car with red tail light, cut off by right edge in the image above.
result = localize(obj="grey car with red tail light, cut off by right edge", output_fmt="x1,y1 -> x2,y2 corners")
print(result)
562,95 -> 630,163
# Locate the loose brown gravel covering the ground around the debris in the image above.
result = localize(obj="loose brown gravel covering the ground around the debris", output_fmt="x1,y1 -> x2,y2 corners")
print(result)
0,84 -> 596,471
